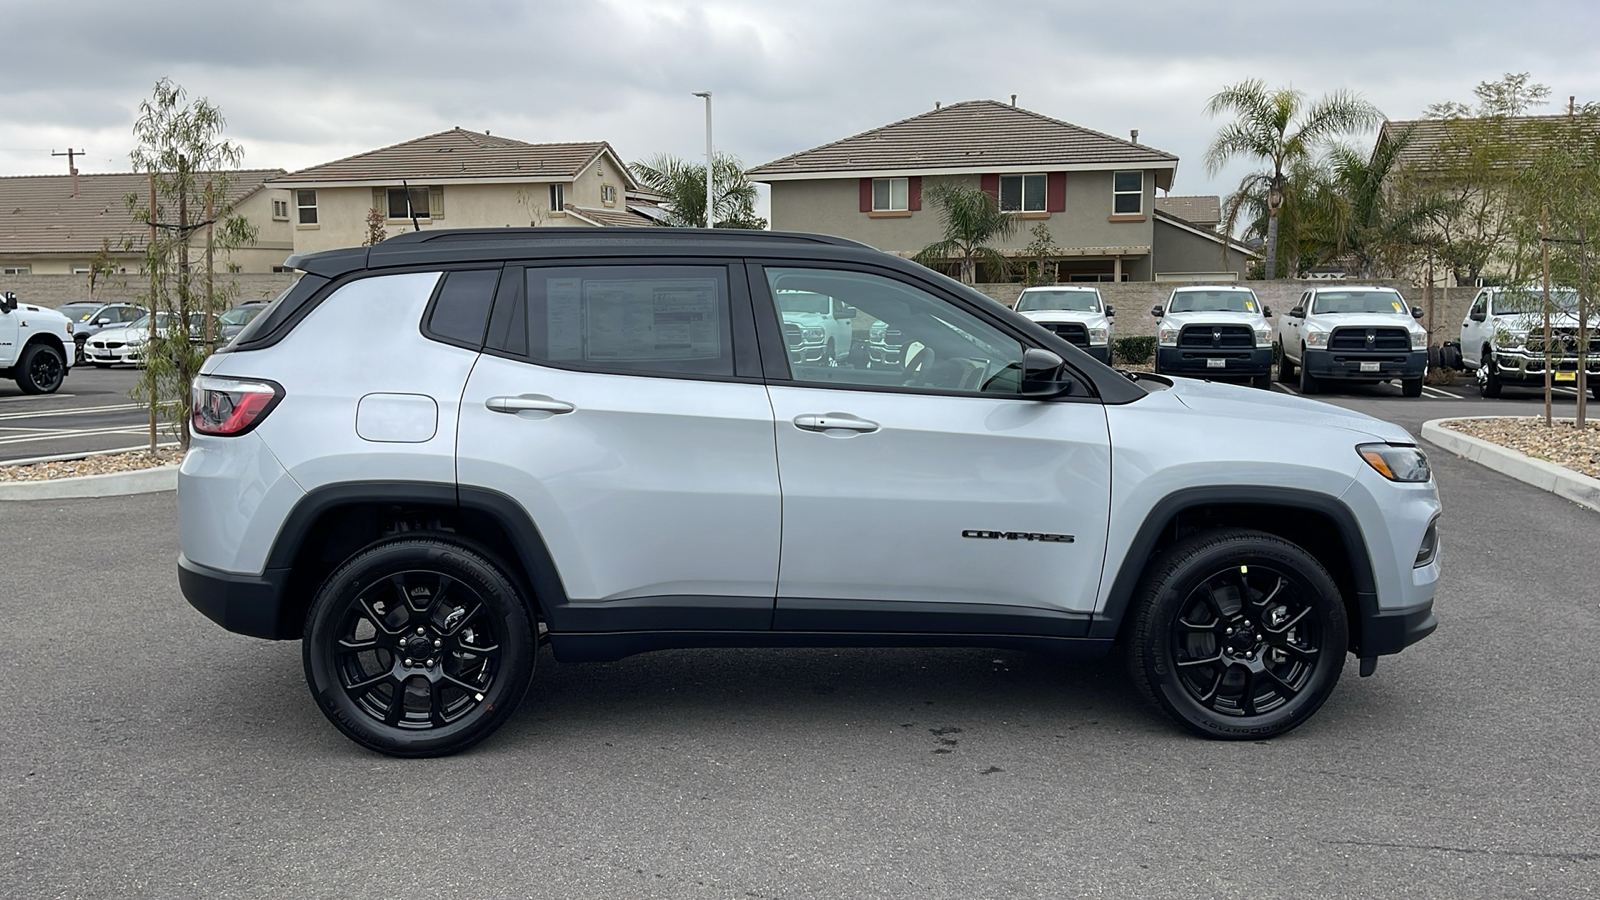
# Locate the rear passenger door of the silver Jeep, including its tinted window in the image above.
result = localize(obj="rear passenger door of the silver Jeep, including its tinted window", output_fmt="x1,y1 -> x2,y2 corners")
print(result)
458,261 -> 781,629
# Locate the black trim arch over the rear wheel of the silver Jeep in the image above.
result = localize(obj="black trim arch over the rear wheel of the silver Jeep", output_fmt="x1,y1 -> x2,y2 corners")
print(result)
267,482 -> 566,639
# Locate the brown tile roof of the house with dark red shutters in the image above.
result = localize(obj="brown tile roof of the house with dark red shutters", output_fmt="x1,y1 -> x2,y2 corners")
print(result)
749,99 -> 1178,181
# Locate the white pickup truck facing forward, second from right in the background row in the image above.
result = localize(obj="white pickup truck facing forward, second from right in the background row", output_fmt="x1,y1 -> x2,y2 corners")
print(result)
1277,285 -> 1427,397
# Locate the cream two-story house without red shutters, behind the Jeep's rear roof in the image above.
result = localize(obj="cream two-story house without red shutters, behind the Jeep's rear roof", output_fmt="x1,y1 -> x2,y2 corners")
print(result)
272,128 -> 651,253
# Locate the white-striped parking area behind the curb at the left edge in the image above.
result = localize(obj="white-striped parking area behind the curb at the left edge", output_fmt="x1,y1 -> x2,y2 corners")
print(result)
0,365 -> 174,463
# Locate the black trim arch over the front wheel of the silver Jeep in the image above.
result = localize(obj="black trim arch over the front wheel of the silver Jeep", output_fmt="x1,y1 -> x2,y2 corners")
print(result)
1090,485 -> 1378,653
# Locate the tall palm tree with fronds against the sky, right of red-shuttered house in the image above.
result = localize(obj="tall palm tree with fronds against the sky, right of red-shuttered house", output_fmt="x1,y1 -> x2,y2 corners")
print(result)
1205,78 -> 1384,279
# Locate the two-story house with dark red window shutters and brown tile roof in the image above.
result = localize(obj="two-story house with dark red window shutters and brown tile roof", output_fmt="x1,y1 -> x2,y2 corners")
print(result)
749,99 -> 1253,282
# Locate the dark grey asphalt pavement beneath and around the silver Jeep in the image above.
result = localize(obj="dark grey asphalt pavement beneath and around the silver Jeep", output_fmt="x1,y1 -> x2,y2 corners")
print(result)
0,383 -> 1600,898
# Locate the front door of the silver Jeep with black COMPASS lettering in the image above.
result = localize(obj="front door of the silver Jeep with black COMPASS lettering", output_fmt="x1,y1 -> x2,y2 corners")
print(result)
752,266 -> 1110,631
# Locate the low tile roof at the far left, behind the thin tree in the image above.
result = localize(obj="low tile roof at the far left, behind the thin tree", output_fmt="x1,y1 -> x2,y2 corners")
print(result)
0,168 -> 283,256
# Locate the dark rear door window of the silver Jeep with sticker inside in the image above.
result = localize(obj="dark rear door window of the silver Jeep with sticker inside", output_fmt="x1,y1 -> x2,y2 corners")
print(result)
523,266 -> 733,376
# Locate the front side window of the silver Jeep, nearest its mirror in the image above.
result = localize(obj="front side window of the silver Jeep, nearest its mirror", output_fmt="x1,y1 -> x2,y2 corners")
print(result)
766,267 -> 1022,394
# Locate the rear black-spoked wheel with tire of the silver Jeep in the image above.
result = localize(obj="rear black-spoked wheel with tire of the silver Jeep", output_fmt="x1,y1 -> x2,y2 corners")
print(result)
302,536 -> 536,757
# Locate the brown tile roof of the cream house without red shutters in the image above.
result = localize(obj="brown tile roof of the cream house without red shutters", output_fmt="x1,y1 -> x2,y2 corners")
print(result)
268,128 -> 634,187
